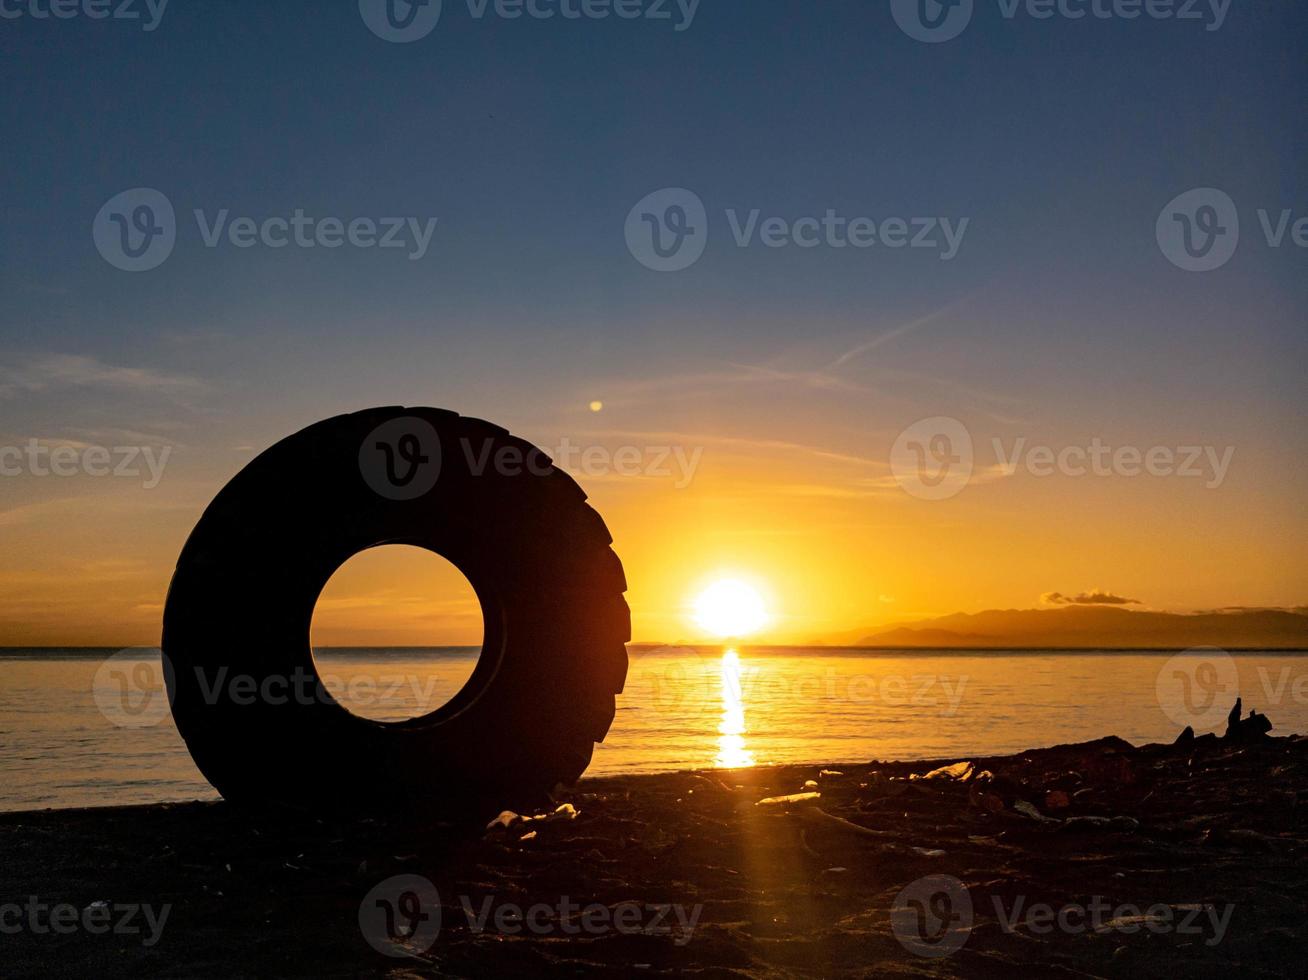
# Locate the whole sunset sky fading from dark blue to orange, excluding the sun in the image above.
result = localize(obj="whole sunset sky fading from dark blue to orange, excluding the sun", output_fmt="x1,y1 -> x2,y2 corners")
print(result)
0,0 -> 1308,646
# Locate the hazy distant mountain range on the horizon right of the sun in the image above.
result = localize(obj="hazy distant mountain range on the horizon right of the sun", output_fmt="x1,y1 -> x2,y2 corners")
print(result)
823,606 -> 1308,649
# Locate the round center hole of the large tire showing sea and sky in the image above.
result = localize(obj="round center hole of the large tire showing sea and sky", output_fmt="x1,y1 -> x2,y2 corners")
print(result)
310,544 -> 484,722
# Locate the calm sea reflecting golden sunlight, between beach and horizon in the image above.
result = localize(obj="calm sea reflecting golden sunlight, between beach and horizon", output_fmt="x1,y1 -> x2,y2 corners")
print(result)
0,644 -> 1308,811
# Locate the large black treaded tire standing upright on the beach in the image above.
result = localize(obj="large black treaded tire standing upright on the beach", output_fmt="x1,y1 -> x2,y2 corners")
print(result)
164,408 -> 630,811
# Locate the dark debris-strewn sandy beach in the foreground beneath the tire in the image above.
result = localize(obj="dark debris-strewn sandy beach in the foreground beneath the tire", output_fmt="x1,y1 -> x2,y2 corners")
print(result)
0,738 -> 1308,977
